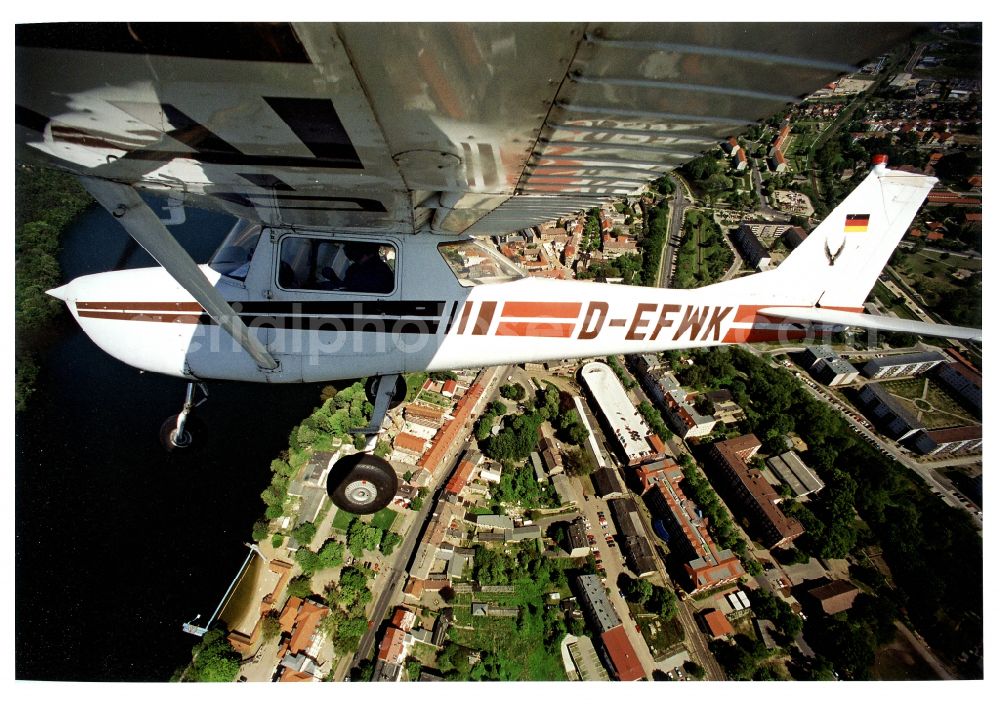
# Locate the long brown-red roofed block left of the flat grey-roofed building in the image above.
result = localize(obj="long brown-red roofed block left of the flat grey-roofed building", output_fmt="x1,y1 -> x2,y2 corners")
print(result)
710,434 -> 805,549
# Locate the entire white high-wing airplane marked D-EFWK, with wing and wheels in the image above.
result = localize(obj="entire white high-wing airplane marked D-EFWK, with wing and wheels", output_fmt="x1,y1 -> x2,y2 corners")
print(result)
16,24 -> 980,513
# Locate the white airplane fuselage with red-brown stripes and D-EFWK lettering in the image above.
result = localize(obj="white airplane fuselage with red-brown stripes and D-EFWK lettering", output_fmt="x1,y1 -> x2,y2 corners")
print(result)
59,229 -> 820,383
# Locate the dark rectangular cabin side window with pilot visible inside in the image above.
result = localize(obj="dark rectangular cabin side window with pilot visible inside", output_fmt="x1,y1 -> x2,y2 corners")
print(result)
278,236 -> 396,294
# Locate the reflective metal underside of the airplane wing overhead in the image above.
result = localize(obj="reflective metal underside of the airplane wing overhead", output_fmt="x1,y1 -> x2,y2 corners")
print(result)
15,22 -> 913,235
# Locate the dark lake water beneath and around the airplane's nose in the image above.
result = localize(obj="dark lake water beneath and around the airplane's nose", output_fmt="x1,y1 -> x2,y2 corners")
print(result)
15,199 -> 319,681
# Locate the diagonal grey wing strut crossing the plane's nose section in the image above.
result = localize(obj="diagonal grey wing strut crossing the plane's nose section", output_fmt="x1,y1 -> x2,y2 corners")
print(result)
80,176 -> 278,371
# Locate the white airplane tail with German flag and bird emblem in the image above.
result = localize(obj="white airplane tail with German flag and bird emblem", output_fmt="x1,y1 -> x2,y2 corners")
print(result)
704,157 -> 982,339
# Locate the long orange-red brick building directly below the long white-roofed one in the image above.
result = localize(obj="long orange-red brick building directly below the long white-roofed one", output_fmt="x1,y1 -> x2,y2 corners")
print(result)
636,459 -> 744,593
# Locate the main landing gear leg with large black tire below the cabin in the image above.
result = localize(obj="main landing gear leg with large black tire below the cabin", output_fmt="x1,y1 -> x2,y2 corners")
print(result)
326,374 -> 406,514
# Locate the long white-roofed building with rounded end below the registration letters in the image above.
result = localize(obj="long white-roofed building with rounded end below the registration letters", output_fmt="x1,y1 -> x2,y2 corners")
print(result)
584,362 -> 655,465
